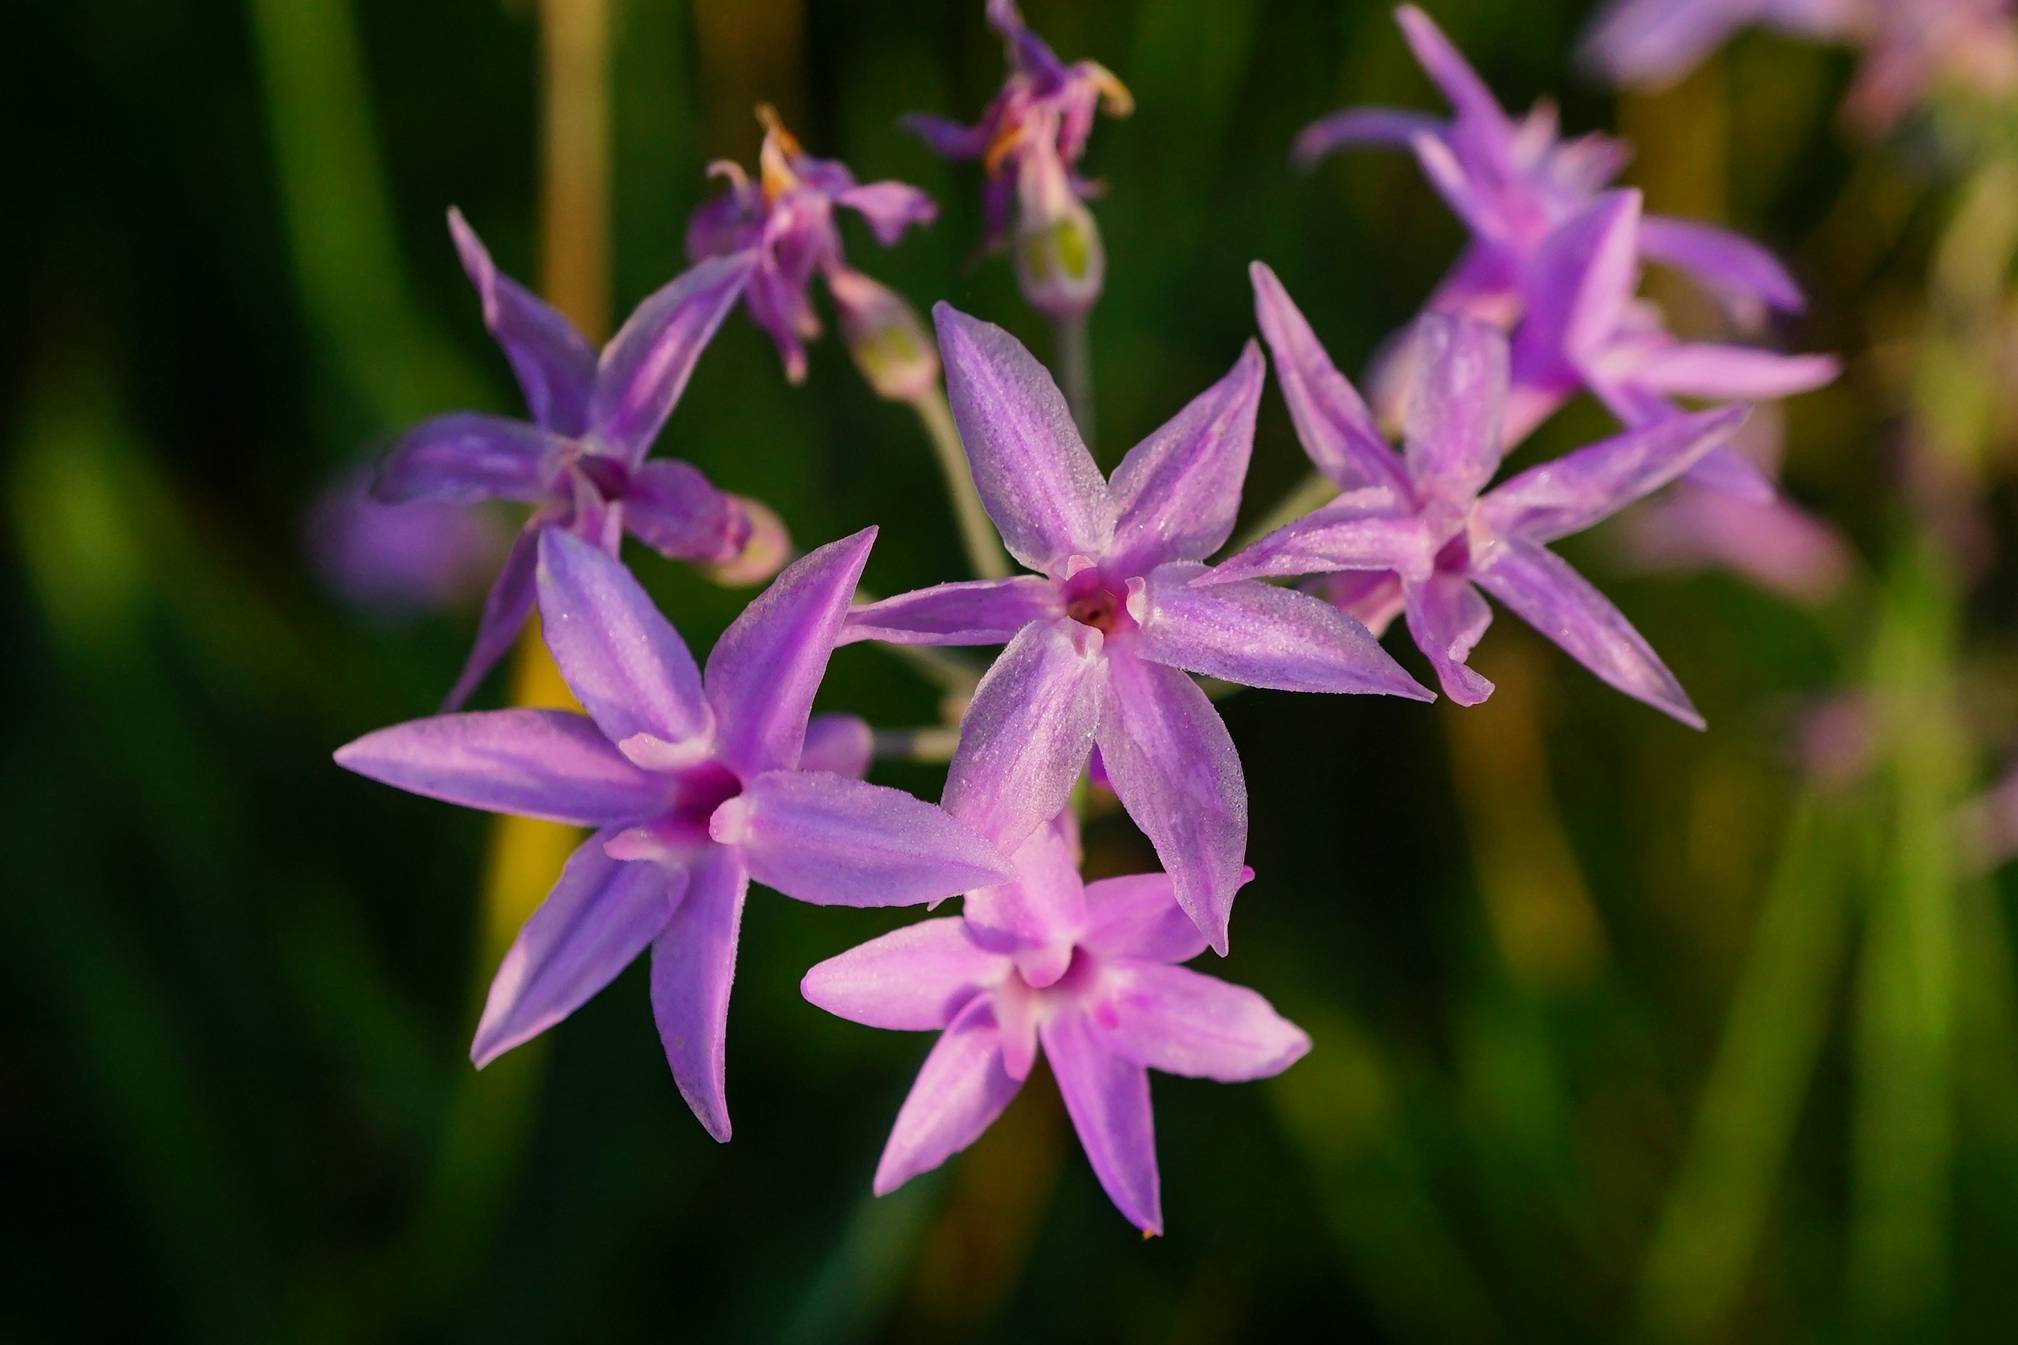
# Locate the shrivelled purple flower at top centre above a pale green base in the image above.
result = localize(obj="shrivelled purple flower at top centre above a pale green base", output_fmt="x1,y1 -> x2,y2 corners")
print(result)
904,0 -> 1134,319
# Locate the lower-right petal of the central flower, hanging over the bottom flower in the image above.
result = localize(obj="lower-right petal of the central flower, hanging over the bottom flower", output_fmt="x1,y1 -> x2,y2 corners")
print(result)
1098,651 -> 1247,956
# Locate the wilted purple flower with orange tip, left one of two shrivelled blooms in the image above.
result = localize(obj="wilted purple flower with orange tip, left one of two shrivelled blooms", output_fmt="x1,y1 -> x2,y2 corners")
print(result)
686,107 -> 938,401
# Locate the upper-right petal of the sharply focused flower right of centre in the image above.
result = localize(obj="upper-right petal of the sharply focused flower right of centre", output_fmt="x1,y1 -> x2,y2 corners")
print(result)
1479,407 -> 1748,542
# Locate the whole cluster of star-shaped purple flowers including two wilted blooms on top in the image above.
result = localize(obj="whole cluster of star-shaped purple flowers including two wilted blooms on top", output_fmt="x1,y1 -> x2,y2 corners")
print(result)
337,0 -> 1834,1232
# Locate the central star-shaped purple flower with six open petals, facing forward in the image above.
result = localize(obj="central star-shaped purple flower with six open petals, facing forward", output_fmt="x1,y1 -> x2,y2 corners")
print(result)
844,304 -> 1431,952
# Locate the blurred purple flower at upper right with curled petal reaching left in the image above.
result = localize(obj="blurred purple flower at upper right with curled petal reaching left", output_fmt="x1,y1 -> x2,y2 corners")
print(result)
1296,6 -> 1802,327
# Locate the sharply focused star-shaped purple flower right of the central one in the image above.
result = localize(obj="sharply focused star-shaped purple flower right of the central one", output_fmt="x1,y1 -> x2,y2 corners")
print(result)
1197,262 -> 1746,728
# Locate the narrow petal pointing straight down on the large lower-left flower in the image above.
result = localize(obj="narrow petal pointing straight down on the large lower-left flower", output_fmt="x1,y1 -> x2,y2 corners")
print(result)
652,845 -> 749,1143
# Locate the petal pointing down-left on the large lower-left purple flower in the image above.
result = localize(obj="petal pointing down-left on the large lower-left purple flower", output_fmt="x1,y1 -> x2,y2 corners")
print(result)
470,831 -> 686,1069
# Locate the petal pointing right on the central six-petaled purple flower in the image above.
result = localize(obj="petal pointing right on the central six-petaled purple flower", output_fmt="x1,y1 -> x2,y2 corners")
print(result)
1140,565 -> 1435,700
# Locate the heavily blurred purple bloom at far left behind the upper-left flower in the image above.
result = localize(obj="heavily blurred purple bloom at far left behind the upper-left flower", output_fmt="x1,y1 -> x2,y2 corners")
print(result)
303,468 -> 511,613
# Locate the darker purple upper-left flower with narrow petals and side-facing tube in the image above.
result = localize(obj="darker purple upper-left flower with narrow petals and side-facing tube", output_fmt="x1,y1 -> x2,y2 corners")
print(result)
375,210 -> 787,710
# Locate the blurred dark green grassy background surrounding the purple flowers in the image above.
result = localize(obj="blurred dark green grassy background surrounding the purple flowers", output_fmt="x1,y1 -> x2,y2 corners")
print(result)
0,0 -> 2018,1341
